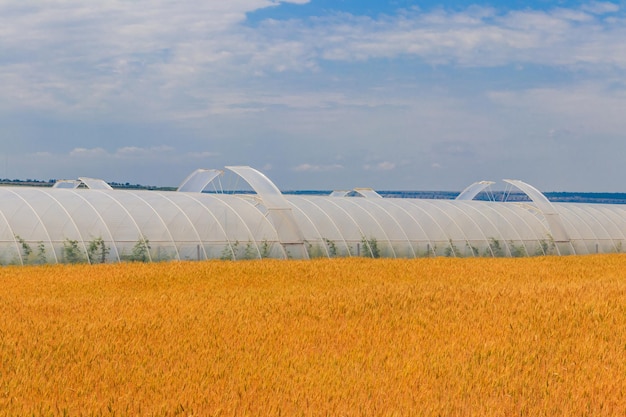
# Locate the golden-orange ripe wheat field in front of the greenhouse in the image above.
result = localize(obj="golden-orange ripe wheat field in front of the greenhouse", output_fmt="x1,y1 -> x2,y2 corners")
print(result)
0,255 -> 626,416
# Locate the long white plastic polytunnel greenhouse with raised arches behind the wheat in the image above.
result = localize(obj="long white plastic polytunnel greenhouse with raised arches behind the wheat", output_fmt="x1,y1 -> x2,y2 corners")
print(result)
0,166 -> 626,265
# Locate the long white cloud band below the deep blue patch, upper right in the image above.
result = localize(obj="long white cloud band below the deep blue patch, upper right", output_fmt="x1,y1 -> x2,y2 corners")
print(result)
311,8 -> 626,67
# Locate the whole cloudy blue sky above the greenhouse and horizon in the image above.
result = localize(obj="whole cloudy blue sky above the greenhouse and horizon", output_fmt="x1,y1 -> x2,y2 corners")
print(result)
0,0 -> 626,192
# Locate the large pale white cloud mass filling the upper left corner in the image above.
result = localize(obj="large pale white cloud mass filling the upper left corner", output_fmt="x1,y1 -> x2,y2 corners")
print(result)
0,0 -> 314,113
